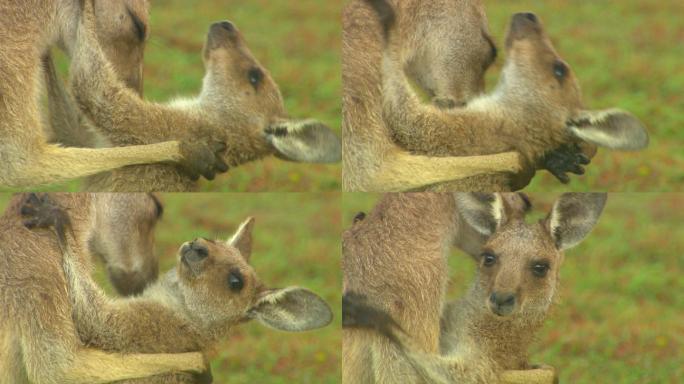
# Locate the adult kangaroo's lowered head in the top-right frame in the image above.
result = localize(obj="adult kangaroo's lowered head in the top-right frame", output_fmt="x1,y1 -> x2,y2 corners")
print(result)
399,0 -> 497,108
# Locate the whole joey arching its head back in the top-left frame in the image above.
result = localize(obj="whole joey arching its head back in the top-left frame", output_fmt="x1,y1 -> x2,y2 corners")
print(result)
59,0 -> 341,191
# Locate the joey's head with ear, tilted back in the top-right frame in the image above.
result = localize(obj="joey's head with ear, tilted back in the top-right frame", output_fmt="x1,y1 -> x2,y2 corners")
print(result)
499,13 -> 648,150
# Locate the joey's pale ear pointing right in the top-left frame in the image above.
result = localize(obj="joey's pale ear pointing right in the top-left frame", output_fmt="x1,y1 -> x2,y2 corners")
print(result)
265,120 -> 342,163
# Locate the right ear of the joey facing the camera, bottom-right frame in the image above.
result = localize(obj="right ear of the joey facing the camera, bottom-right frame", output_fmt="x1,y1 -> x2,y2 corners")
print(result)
545,193 -> 608,251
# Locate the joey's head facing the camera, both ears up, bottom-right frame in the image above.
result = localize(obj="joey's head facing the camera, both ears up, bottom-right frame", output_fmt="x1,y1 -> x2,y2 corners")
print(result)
456,193 -> 606,319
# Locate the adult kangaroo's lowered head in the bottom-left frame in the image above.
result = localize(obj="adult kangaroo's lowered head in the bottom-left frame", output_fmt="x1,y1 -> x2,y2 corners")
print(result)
87,193 -> 163,295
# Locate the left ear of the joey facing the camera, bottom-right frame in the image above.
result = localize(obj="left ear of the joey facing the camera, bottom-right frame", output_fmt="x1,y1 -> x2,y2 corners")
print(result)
454,193 -> 507,237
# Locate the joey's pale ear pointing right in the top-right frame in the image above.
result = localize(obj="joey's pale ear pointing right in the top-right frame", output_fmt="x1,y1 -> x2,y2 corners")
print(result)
566,109 -> 649,151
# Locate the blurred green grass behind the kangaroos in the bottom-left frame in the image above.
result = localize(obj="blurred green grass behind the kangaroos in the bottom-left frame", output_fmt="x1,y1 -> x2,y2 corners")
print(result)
0,193 -> 342,384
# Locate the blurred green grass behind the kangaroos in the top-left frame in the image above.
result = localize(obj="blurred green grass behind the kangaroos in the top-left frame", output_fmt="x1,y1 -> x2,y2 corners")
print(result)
23,0 -> 342,192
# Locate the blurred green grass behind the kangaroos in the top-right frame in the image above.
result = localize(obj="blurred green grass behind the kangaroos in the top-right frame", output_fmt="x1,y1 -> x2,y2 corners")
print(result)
483,0 -> 684,192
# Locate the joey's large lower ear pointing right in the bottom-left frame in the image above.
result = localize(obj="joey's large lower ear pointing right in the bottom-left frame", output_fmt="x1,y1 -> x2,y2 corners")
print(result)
249,287 -> 332,332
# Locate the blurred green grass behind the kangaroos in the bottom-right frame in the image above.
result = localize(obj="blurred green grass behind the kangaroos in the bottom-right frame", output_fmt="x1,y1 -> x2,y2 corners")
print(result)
342,193 -> 684,384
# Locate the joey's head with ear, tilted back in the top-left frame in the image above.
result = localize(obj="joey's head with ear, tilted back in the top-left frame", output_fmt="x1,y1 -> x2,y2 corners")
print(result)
201,21 -> 341,163
